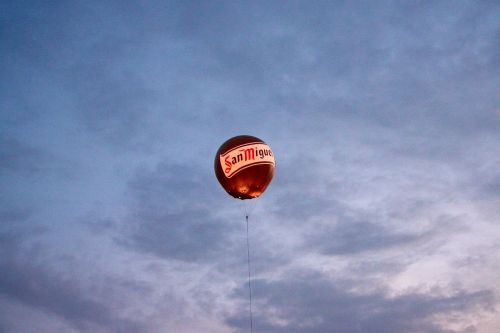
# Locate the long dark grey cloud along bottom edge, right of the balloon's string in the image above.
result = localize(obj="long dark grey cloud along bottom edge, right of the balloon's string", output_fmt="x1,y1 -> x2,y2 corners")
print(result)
228,272 -> 494,333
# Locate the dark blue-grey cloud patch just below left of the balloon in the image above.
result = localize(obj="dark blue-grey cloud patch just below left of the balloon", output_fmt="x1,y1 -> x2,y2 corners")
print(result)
119,163 -> 240,262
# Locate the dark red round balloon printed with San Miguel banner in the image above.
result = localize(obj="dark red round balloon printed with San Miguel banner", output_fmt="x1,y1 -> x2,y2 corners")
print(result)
214,135 -> 276,200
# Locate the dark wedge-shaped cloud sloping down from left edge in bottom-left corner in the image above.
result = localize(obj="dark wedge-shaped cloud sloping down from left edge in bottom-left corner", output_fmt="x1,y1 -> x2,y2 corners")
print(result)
0,220 -> 148,332
